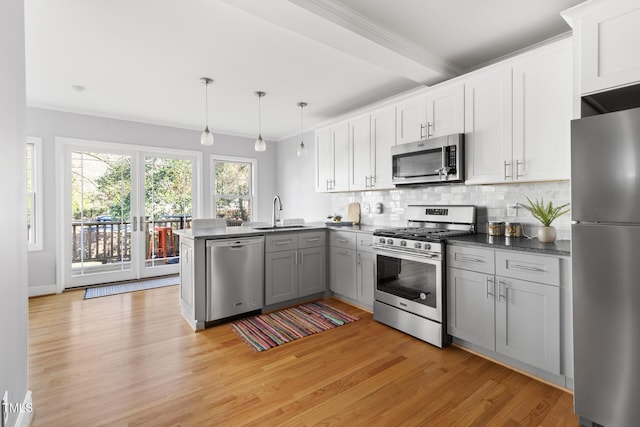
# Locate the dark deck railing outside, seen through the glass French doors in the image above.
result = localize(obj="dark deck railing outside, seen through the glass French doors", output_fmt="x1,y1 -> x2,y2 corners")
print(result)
71,218 -> 191,264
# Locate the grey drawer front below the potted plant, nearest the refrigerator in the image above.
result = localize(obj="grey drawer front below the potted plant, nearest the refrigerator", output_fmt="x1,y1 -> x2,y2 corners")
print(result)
496,251 -> 560,286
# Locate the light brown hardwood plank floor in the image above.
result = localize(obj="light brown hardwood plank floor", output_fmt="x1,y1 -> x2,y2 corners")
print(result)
29,286 -> 578,426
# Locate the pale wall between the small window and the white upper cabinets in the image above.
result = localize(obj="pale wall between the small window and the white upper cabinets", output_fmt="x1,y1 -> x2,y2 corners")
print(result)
277,132 -> 332,221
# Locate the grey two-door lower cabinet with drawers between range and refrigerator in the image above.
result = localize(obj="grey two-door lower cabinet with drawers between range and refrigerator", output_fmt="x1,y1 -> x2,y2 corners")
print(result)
447,245 -> 560,375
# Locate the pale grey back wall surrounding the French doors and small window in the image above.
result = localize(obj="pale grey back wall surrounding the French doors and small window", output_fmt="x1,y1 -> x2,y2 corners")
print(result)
27,108 -> 277,294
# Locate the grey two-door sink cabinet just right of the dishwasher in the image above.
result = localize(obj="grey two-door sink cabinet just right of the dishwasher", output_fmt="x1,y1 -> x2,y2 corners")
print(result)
265,231 -> 326,305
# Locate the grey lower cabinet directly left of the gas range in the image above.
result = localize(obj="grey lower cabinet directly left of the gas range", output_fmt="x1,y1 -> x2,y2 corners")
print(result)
329,231 -> 374,309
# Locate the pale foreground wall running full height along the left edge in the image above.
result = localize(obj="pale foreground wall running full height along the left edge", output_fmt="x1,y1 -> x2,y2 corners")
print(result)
0,0 -> 27,426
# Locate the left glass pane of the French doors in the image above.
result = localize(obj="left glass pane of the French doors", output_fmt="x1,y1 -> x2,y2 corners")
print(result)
71,151 -> 131,276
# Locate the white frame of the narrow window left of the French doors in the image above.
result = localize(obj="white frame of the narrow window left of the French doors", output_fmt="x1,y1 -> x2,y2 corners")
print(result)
25,136 -> 44,252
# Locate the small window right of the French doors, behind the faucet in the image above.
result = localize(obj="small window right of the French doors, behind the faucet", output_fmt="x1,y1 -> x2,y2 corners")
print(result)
211,156 -> 256,225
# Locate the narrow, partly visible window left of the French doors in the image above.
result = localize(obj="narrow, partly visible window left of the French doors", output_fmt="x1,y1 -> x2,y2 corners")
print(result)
25,136 -> 43,251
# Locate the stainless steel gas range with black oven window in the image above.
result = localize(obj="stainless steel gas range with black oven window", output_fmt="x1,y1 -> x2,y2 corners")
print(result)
373,204 -> 476,347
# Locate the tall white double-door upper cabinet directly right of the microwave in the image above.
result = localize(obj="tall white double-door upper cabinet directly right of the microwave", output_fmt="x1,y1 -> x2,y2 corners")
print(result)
465,39 -> 573,184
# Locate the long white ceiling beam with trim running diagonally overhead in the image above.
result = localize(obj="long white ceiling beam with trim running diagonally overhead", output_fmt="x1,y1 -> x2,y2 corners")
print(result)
222,0 -> 462,85
